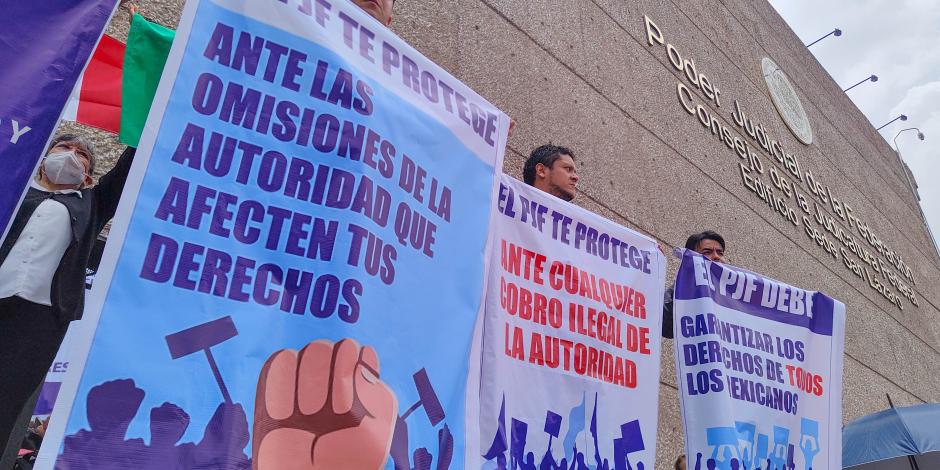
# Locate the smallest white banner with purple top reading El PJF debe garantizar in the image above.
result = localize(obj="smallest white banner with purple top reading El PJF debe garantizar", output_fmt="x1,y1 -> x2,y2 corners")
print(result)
673,251 -> 845,470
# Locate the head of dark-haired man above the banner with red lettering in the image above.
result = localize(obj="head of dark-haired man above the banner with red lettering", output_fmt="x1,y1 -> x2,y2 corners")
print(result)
522,144 -> 578,201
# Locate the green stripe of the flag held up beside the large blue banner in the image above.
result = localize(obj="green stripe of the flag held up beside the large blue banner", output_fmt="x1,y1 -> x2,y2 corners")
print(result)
118,14 -> 176,147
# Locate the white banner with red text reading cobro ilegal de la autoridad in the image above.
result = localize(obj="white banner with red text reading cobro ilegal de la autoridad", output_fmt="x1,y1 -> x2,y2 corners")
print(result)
478,175 -> 665,470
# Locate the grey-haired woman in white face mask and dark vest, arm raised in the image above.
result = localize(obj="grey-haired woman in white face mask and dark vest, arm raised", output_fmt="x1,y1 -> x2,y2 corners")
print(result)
0,135 -> 135,450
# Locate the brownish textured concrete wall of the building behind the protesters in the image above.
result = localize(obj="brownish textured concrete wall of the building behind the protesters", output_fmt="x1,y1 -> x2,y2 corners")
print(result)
79,0 -> 940,469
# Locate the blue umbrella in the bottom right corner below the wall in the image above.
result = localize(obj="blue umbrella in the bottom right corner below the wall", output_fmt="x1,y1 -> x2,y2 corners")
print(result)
842,403 -> 940,470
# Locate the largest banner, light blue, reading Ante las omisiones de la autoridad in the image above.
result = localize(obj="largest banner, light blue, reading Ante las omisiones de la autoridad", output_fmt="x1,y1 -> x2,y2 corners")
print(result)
39,0 -> 509,470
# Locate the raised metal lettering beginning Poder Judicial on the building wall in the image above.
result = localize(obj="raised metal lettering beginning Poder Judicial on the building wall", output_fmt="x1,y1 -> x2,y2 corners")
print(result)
643,16 -> 919,310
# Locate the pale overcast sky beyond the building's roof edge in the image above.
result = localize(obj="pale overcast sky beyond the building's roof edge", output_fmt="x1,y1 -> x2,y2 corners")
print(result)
770,0 -> 940,253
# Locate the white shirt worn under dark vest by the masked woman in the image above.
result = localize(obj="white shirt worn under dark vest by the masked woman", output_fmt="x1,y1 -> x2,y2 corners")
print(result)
0,179 -> 82,306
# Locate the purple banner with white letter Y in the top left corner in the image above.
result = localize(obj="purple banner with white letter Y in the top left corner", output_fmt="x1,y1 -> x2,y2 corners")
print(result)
0,0 -> 117,234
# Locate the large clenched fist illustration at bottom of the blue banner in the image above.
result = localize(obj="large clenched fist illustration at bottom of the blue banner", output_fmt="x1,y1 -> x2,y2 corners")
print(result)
252,339 -> 398,470
